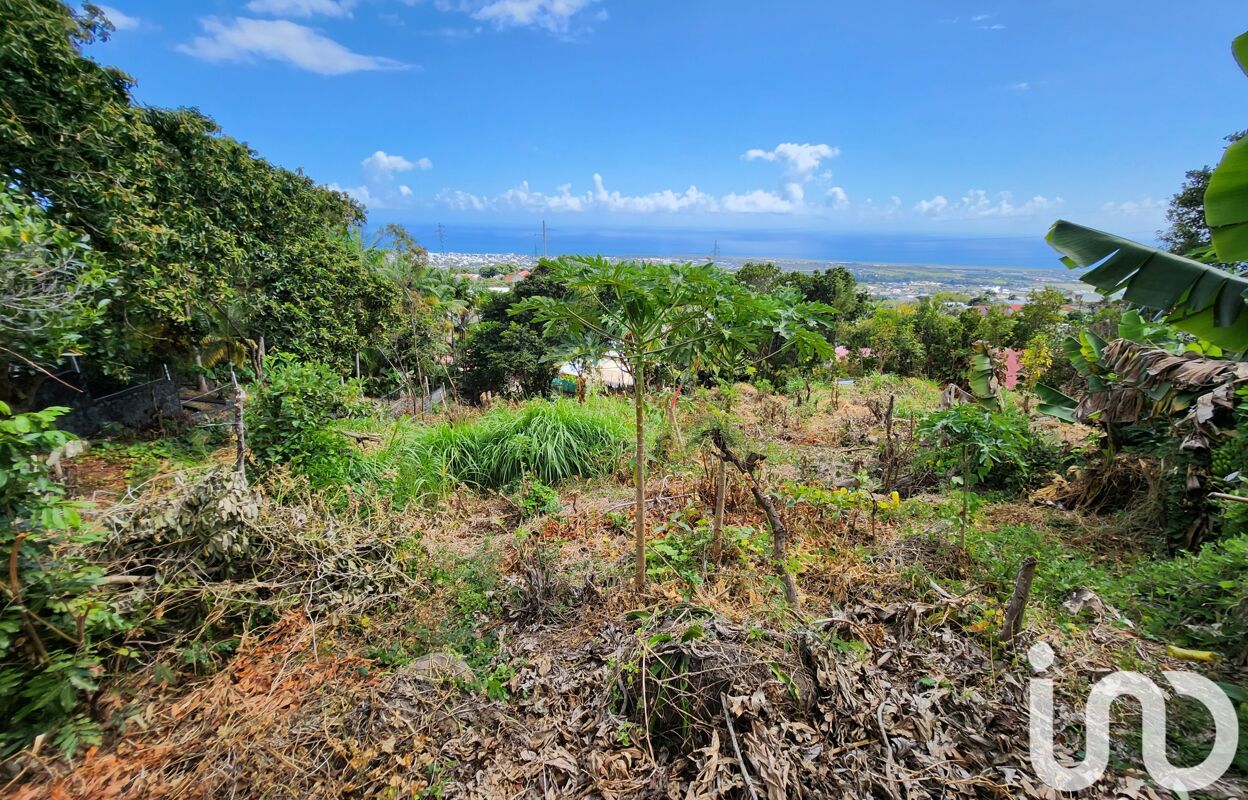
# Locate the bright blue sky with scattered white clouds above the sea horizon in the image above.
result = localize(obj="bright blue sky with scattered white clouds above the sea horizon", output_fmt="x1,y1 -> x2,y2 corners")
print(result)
82,0 -> 1248,260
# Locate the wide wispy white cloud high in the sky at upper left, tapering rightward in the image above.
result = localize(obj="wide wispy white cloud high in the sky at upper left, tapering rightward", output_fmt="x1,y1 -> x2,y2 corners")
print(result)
177,16 -> 407,75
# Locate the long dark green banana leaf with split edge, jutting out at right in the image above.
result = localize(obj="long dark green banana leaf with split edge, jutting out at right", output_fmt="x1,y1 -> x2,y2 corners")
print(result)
1045,222 -> 1248,351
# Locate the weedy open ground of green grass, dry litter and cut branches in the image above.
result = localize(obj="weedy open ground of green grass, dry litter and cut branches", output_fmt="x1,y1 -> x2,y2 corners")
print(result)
5,376 -> 1246,800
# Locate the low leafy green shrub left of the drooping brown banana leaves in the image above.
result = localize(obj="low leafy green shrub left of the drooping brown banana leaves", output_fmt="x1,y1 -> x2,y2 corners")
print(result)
917,403 -> 1061,490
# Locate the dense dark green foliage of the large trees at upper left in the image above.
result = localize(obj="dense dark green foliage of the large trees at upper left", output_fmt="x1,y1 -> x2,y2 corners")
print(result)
0,0 -> 396,373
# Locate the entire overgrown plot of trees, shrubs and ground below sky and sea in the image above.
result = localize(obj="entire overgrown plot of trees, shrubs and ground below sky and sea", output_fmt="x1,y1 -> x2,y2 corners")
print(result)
7,0 -> 1248,798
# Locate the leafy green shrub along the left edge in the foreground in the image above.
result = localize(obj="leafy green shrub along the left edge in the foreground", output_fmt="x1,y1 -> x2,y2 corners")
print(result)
0,403 -> 125,755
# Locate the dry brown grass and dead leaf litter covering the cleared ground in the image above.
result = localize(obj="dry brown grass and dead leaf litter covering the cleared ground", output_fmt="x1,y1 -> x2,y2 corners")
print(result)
2,386 -> 1228,800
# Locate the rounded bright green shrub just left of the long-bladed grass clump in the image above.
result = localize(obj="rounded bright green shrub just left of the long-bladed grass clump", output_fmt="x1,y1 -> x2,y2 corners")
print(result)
245,354 -> 359,483
